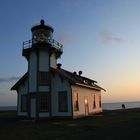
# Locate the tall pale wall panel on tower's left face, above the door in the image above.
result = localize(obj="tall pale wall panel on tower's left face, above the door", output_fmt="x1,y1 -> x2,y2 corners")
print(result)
29,51 -> 37,92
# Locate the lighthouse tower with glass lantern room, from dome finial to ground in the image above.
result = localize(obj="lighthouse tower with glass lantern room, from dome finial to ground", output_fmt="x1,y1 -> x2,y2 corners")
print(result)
22,20 -> 63,118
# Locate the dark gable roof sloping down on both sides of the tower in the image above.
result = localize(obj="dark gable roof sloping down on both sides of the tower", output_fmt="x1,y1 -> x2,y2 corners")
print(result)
11,68 -> 105,91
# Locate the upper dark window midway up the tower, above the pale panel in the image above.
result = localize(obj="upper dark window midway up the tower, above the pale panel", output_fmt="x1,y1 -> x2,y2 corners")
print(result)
39,72 -> 49,85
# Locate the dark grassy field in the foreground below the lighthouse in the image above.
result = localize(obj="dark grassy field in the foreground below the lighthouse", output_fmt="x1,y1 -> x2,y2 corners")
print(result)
0,109 -> 140,140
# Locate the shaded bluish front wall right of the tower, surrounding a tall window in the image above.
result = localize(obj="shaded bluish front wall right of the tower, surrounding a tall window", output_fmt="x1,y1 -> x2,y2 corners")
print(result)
51,73 -> 72,116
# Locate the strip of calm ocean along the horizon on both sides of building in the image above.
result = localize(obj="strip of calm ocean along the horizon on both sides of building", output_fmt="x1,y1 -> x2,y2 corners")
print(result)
0,102 -> 140,110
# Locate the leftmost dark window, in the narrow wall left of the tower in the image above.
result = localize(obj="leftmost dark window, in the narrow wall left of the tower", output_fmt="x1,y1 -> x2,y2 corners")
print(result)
21,95 -> 27,112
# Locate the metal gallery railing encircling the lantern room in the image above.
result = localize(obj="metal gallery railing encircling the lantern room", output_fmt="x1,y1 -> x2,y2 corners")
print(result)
23,39 -> 63,51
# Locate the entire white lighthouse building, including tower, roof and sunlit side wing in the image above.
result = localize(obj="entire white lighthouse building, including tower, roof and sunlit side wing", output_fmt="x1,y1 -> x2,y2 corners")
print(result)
11,20 -> 104,119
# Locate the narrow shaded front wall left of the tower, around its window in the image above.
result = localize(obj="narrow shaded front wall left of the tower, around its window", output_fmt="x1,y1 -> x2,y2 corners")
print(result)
17,80 -> 28,116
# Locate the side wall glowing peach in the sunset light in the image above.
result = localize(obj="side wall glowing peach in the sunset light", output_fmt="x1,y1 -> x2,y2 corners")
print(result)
72,86 -> 102,117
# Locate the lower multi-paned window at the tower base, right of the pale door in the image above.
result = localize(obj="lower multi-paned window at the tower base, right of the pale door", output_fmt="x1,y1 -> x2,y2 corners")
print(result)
39,93 -> 48,112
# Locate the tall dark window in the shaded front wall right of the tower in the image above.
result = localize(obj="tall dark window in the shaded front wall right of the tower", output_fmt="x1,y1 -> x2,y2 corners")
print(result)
58,91 -> 68,112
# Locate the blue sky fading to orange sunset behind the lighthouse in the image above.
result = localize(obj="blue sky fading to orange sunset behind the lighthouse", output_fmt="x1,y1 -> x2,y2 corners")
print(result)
0,0 -> 140,106
